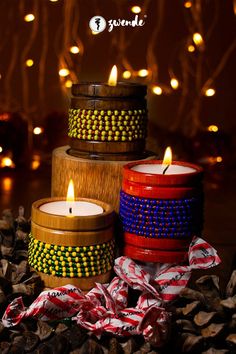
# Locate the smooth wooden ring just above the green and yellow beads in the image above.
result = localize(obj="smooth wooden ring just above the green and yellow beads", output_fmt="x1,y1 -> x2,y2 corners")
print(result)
31,221 -> 114,247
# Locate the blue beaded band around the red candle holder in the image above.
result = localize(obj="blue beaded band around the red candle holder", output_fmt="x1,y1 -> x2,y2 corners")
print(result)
120,191 -> 202,239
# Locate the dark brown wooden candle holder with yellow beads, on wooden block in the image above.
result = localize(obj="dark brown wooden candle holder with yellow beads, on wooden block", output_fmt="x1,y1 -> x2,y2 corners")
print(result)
69,82 -> 147,157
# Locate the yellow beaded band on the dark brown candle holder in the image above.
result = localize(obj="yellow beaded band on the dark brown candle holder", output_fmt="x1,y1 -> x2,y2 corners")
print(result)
68,108 -> 147,142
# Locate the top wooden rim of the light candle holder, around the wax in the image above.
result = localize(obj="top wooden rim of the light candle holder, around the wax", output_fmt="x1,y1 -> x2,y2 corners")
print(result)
32,198 -> 114,231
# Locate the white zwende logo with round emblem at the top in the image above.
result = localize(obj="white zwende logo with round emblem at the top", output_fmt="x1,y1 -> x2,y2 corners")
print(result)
89,15 -> 146,32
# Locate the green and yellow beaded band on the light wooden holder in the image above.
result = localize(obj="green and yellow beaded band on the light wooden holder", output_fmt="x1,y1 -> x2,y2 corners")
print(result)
29,234 -> 114,278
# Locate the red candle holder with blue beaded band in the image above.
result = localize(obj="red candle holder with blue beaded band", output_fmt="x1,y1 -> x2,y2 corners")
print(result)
120,160 -> 203,263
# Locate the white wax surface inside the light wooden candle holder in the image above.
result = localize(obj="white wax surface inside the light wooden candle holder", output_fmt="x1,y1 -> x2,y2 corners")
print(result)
39,200 -> 103,216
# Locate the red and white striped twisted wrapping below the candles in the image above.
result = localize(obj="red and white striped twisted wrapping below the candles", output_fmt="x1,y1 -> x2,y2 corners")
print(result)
2,237 -> 220,345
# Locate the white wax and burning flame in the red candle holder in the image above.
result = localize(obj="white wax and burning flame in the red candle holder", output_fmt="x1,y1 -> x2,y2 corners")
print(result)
132,147 -> 196,175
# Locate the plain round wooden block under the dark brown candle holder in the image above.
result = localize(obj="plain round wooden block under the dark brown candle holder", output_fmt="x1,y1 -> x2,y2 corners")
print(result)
51,146 -> 154,212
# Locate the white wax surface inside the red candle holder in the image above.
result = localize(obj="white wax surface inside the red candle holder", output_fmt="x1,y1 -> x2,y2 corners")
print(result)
132,164 -> 196,175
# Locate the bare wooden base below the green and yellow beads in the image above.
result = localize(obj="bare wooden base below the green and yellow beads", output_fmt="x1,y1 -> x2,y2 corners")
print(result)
37,271 -> 111,291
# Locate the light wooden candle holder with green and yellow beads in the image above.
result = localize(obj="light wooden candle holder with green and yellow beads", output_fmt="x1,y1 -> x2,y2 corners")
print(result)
29,198 -> 114,290
